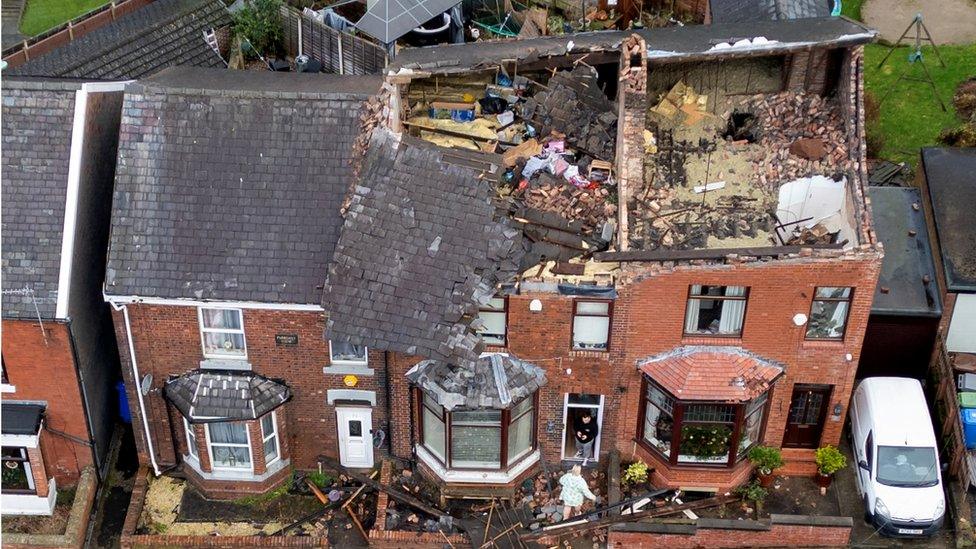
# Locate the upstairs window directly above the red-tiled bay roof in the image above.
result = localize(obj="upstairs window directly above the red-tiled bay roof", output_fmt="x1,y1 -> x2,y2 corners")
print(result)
685,284 -> 749,336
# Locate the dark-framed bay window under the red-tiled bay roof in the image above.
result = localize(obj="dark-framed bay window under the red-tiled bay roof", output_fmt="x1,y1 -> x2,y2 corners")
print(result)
638,377 -> 769,466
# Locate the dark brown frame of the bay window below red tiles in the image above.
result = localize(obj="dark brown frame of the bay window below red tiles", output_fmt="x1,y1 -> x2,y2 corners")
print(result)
637,375 -> 773,469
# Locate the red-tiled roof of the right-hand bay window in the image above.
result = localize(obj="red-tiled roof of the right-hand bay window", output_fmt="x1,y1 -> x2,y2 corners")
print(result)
637,345 -> 786,402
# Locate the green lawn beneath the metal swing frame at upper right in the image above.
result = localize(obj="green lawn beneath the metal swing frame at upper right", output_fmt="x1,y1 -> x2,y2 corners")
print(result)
864,44 -> 976,165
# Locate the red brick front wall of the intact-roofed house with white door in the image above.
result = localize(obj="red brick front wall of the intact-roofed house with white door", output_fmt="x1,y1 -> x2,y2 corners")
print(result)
113,304 -> 388,480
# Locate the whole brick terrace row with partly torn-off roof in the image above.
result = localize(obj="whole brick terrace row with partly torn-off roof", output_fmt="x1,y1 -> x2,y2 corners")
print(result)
105,11 -> 882,506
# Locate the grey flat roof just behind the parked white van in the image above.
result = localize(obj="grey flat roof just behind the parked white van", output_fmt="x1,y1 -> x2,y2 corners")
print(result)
868,187 -> 942,317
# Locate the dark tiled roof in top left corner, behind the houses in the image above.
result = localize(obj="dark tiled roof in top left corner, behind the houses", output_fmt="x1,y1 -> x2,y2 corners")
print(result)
4,0 -> 231,80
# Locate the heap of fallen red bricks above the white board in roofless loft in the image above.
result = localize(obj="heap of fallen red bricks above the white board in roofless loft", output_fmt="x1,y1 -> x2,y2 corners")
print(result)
748,92 -> 853,184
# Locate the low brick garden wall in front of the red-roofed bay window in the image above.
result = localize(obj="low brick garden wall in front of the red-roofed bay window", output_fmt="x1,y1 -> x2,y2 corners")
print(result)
607,515 -> 854,549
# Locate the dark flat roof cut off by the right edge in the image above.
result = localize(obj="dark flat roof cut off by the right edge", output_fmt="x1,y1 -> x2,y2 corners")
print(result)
922,147 -> 976,292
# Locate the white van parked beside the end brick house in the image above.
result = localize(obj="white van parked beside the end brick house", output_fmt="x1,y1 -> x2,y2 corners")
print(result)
850,377 -> 945,536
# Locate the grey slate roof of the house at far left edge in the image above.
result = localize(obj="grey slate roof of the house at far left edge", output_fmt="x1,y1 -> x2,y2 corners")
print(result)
0,77 -> 78,318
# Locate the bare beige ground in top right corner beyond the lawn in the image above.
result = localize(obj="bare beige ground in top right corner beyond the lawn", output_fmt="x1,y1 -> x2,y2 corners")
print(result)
861,0 -> 976,44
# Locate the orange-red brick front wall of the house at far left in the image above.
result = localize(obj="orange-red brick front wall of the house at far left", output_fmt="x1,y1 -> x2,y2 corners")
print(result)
2,319 -> 92,489
